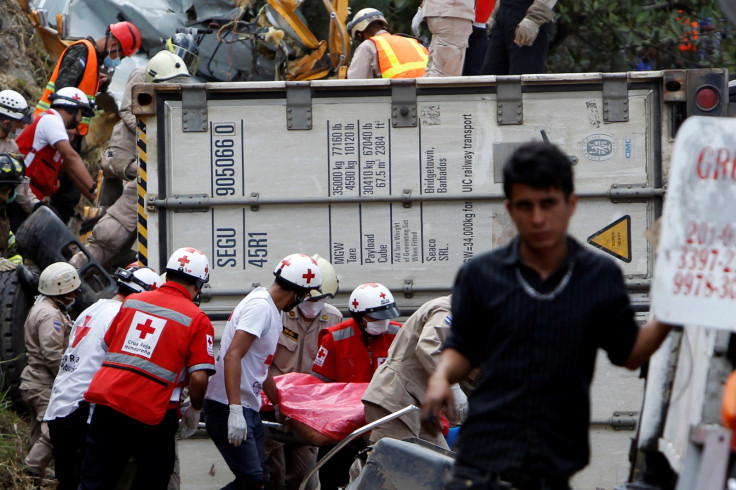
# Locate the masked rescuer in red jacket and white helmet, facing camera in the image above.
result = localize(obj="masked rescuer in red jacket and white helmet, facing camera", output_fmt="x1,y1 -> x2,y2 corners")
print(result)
312,282 -> 401,383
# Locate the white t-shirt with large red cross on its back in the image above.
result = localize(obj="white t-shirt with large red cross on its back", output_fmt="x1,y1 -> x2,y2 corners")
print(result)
44,299 -> 122,421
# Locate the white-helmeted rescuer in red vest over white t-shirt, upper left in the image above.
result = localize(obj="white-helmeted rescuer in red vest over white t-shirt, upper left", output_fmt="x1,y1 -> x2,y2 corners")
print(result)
11,87 -> 96,229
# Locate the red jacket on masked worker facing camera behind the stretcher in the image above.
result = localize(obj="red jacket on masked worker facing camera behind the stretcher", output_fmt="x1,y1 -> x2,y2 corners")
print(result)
312,318 -> 401,383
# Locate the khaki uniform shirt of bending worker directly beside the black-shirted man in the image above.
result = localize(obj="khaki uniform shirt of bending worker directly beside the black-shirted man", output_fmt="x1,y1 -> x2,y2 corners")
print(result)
363,296 -> 478,434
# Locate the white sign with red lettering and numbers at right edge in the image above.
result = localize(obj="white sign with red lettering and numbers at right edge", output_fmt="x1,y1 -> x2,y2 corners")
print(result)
652,117 -> 736,330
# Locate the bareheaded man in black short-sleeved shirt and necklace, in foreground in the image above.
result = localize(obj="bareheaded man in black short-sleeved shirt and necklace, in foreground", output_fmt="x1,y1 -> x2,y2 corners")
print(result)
422,143 -> 671,490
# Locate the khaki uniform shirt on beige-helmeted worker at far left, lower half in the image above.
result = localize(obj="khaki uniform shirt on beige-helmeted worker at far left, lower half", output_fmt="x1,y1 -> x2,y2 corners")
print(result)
20,296 -> 72,390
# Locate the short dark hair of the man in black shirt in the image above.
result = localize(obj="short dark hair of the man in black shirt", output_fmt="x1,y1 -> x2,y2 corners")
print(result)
503,141 -> 575,199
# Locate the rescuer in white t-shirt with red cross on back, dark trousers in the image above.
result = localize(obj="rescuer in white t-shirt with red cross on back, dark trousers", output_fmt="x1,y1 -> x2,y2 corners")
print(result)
44,265 -> 163,490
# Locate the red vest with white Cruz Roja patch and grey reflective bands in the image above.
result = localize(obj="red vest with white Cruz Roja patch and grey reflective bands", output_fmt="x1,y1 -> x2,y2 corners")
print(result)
84,282 -> 214,425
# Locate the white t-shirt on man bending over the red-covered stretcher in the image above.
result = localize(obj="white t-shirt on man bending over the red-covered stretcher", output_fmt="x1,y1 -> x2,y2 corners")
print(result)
205,287 -> 283,411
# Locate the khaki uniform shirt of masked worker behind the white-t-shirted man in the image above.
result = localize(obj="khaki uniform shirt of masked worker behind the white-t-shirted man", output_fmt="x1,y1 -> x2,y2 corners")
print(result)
271,302 -> 344,376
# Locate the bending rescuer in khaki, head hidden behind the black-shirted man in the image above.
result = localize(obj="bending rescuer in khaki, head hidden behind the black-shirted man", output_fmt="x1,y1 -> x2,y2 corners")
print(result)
363,296 -> 477,449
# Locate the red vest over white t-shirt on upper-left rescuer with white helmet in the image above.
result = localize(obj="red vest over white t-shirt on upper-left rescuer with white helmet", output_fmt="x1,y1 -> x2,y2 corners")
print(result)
15,109 -> 63,199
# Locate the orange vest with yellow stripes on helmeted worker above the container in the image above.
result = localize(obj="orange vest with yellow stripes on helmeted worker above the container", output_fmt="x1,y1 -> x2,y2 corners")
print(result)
370,32 -> 429,78
